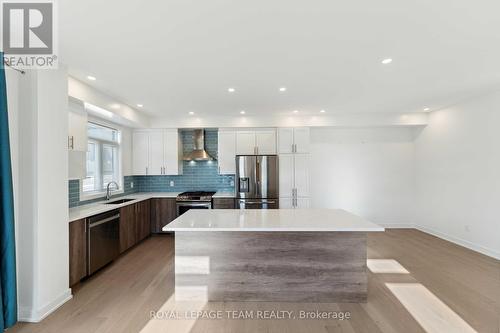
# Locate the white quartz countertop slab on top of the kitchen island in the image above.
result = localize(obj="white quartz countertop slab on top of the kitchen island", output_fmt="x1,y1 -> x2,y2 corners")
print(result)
163,209 -> 384,232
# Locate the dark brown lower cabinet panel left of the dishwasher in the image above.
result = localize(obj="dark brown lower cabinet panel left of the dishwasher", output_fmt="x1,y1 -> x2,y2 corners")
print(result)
69,219 -> 87,286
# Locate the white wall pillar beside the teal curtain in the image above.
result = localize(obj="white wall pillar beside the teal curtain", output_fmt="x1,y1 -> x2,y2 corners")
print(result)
16,65 -> 71,321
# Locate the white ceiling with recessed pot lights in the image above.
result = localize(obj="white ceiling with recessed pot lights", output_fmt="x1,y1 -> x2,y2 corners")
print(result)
58,0 -> 500,117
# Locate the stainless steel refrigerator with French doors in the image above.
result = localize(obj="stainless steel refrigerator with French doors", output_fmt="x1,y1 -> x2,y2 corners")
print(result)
236,155 -> 279,209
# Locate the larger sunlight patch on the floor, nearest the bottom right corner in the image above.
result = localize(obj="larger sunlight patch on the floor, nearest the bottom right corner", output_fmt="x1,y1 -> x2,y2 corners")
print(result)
385,283 -> 477,333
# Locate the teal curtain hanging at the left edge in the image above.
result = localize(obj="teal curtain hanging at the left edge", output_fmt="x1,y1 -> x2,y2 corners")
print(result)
0,52 -> 17,331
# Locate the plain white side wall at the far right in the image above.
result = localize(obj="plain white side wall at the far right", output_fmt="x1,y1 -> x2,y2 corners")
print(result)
416,92 -> 500,258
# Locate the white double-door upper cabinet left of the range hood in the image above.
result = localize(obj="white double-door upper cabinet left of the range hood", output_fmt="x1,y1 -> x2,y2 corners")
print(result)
132,129 -> 182,175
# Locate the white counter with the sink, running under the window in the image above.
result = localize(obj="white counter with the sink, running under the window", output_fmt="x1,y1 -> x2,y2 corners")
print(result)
69,192 -> 181,222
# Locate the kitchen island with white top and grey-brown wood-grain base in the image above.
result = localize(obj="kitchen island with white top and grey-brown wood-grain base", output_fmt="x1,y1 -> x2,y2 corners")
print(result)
163,209 -> 384,303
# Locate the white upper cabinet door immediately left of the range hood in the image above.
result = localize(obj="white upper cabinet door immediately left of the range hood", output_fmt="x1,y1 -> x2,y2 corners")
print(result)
163,128 -> 183,175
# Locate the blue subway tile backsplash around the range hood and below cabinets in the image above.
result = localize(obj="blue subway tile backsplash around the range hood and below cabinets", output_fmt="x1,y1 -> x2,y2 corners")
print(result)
68,129 -> 235,207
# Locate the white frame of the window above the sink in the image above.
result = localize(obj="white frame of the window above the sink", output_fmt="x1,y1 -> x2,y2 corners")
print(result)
80,117 -> 125,201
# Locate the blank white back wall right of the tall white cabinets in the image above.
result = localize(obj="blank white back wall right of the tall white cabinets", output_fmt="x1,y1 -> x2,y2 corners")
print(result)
310,127 -> 415,226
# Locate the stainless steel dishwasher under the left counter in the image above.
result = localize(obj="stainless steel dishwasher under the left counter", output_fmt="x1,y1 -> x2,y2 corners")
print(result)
87,210 -> 120,275
